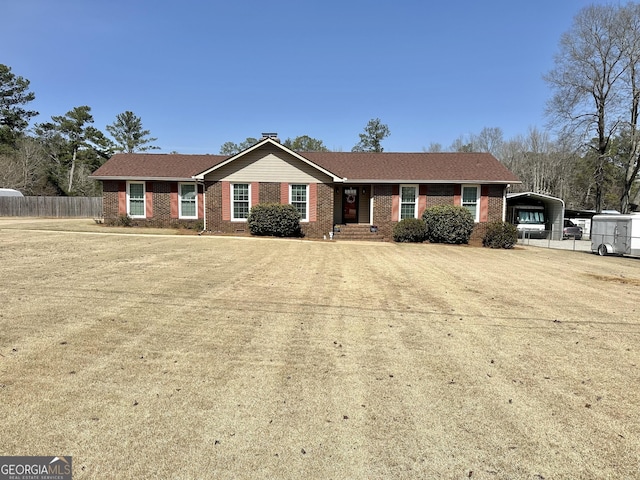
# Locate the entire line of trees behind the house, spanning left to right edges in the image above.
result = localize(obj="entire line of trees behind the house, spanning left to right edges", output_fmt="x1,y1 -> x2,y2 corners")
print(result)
0,3 -> 640,213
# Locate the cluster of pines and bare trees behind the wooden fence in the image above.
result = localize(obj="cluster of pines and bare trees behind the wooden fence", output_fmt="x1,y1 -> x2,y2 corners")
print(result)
0,64 -> 158,196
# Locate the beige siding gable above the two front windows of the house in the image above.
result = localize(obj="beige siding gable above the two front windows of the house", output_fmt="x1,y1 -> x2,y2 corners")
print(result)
205,146 -> 332,184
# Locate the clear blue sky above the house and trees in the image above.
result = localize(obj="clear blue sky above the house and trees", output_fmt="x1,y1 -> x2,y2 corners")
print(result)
5,0 -> 602,153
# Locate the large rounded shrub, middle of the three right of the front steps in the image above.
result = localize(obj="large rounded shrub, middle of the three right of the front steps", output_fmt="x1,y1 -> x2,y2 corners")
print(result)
422,205 -> 475,244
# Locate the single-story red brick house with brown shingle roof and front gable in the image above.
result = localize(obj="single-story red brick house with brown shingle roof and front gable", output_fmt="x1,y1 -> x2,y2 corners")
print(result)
91,137 -> 520,240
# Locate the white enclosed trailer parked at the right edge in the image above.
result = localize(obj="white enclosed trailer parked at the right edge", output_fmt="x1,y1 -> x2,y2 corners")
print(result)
591,213 -> 640,257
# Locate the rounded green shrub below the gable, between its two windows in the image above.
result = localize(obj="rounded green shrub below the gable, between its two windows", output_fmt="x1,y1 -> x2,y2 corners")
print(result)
247,203 -> 302,237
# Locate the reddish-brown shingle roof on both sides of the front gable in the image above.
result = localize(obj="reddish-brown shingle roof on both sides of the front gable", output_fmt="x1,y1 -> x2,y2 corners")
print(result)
92,152 -> 519,183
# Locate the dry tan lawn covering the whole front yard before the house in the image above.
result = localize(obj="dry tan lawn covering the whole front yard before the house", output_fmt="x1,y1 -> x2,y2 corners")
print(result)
0,218 -> 640,479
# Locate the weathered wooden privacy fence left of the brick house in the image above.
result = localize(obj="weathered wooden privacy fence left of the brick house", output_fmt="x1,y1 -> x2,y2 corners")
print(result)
0,197 -> 102,218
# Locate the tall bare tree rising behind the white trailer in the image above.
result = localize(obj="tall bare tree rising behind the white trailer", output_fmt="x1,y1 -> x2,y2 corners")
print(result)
545,3 -> 640,212
